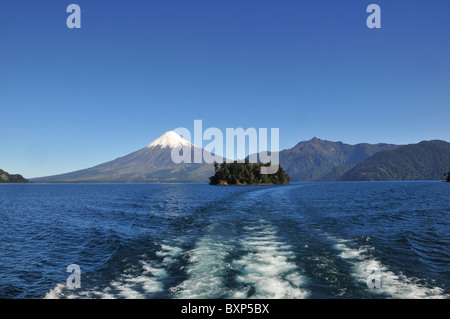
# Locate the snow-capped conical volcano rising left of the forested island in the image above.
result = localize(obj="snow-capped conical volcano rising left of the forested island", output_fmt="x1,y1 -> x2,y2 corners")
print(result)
31,131 -> 214,183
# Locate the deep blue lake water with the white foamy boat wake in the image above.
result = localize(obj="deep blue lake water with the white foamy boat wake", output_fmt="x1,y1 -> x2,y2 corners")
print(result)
0,181 -> 450,298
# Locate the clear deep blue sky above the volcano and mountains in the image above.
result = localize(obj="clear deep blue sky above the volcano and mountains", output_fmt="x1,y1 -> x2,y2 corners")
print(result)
0,0 -> 450,177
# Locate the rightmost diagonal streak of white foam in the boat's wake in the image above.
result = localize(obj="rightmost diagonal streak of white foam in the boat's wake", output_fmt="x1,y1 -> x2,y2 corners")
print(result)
334,240 -> 449,299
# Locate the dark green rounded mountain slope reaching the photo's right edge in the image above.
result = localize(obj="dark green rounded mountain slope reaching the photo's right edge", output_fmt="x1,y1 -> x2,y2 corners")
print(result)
339,140 -> 450,181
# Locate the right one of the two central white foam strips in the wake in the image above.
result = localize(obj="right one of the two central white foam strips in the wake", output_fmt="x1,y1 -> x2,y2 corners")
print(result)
231,224 -> 309,299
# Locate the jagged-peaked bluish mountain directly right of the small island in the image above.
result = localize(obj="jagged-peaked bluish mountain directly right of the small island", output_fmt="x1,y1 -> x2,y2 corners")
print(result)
280,137 -> 399,182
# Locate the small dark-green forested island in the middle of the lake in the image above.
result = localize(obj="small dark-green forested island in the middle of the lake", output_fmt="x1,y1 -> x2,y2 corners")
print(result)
209,160 -> 291,185
